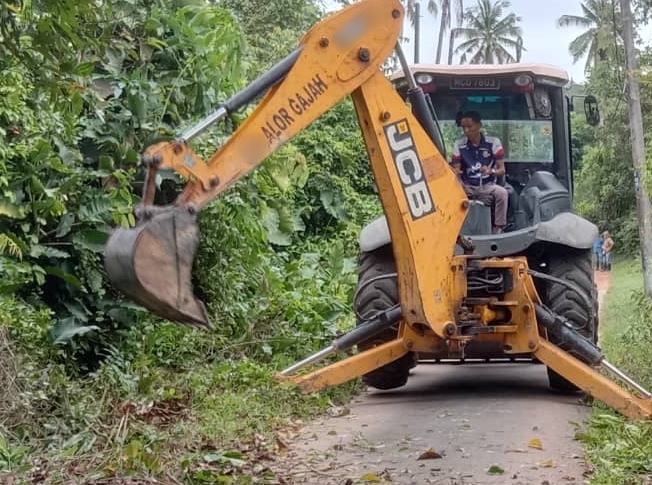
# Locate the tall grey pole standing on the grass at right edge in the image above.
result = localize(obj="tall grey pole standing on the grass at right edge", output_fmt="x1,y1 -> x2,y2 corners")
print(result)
620,0 -> 652,296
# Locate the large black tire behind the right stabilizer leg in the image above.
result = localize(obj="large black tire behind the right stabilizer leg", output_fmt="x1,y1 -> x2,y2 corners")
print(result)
544,248 -> 598,393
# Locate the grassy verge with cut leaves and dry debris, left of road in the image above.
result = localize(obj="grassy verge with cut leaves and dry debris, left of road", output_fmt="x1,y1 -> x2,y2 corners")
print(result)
0,326 -> 358,485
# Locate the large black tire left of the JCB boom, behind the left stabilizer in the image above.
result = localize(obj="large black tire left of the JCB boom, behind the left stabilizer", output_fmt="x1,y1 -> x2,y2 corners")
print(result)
355,245 -> 415,389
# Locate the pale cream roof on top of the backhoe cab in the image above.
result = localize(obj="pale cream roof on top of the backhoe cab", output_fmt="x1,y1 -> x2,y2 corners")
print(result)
390,63 -> 570,84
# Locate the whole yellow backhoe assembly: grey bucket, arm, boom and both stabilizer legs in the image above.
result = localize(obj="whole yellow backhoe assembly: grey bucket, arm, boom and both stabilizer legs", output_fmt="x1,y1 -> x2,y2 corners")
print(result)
105,0 -> 652,417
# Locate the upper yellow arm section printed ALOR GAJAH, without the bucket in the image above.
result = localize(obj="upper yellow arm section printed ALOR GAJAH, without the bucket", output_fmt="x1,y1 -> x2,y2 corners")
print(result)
144,0 -> 403,208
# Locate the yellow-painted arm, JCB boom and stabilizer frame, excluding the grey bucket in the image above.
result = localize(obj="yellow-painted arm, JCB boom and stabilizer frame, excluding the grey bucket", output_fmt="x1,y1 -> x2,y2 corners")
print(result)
123,0 -> 651,417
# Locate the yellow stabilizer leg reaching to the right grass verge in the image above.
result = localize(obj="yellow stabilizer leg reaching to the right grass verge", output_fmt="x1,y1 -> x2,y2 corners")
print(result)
534,339 -> 652,419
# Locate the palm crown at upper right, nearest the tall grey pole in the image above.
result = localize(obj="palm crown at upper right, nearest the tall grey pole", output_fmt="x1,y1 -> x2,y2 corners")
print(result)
557,0 -> 619,71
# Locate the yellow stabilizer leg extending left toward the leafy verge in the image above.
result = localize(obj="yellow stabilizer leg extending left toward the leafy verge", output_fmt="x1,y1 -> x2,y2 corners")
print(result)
285,337 -> 408,392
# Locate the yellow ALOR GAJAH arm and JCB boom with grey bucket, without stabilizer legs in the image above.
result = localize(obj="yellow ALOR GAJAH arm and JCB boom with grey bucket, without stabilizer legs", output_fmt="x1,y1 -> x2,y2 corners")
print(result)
105,0 -> 466,326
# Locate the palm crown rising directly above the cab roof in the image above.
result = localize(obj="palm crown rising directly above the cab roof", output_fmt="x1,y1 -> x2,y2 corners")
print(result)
452,0 -> 524,64
